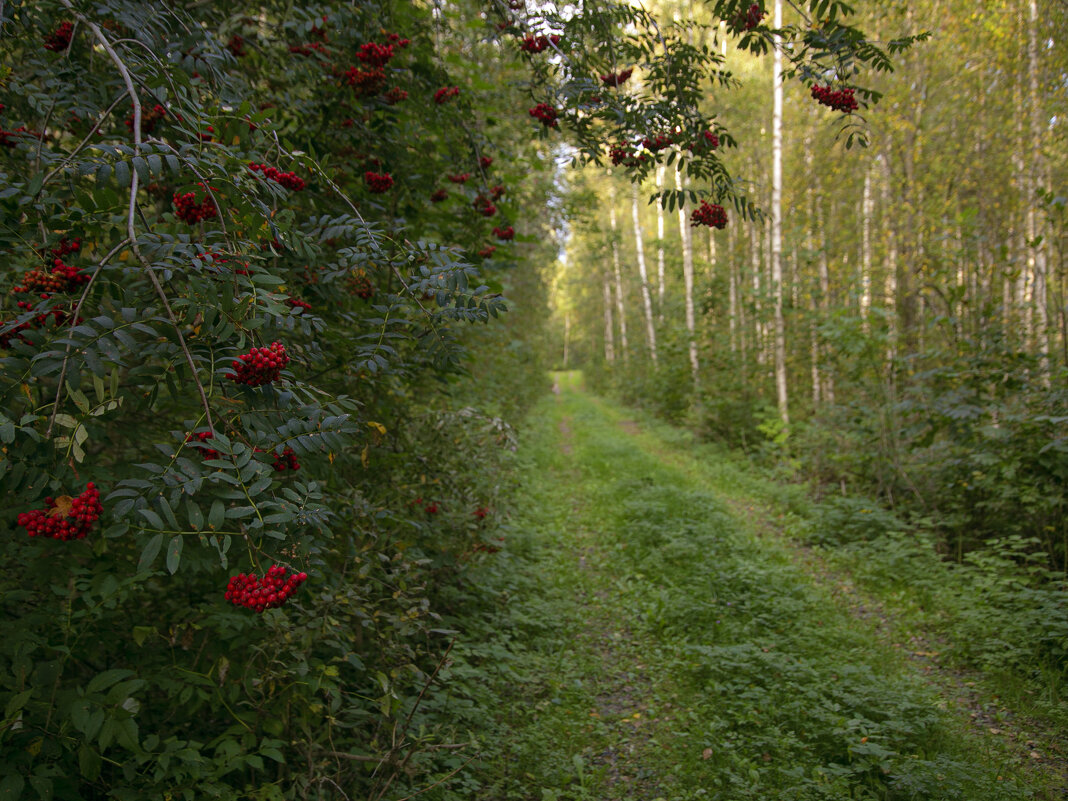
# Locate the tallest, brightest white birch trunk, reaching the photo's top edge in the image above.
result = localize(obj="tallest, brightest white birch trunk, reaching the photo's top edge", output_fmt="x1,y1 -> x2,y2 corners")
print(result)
771,0 -> 790,424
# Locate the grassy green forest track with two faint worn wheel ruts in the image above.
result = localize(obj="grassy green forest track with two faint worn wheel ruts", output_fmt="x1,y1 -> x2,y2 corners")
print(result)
430,374 -> 1064,801
